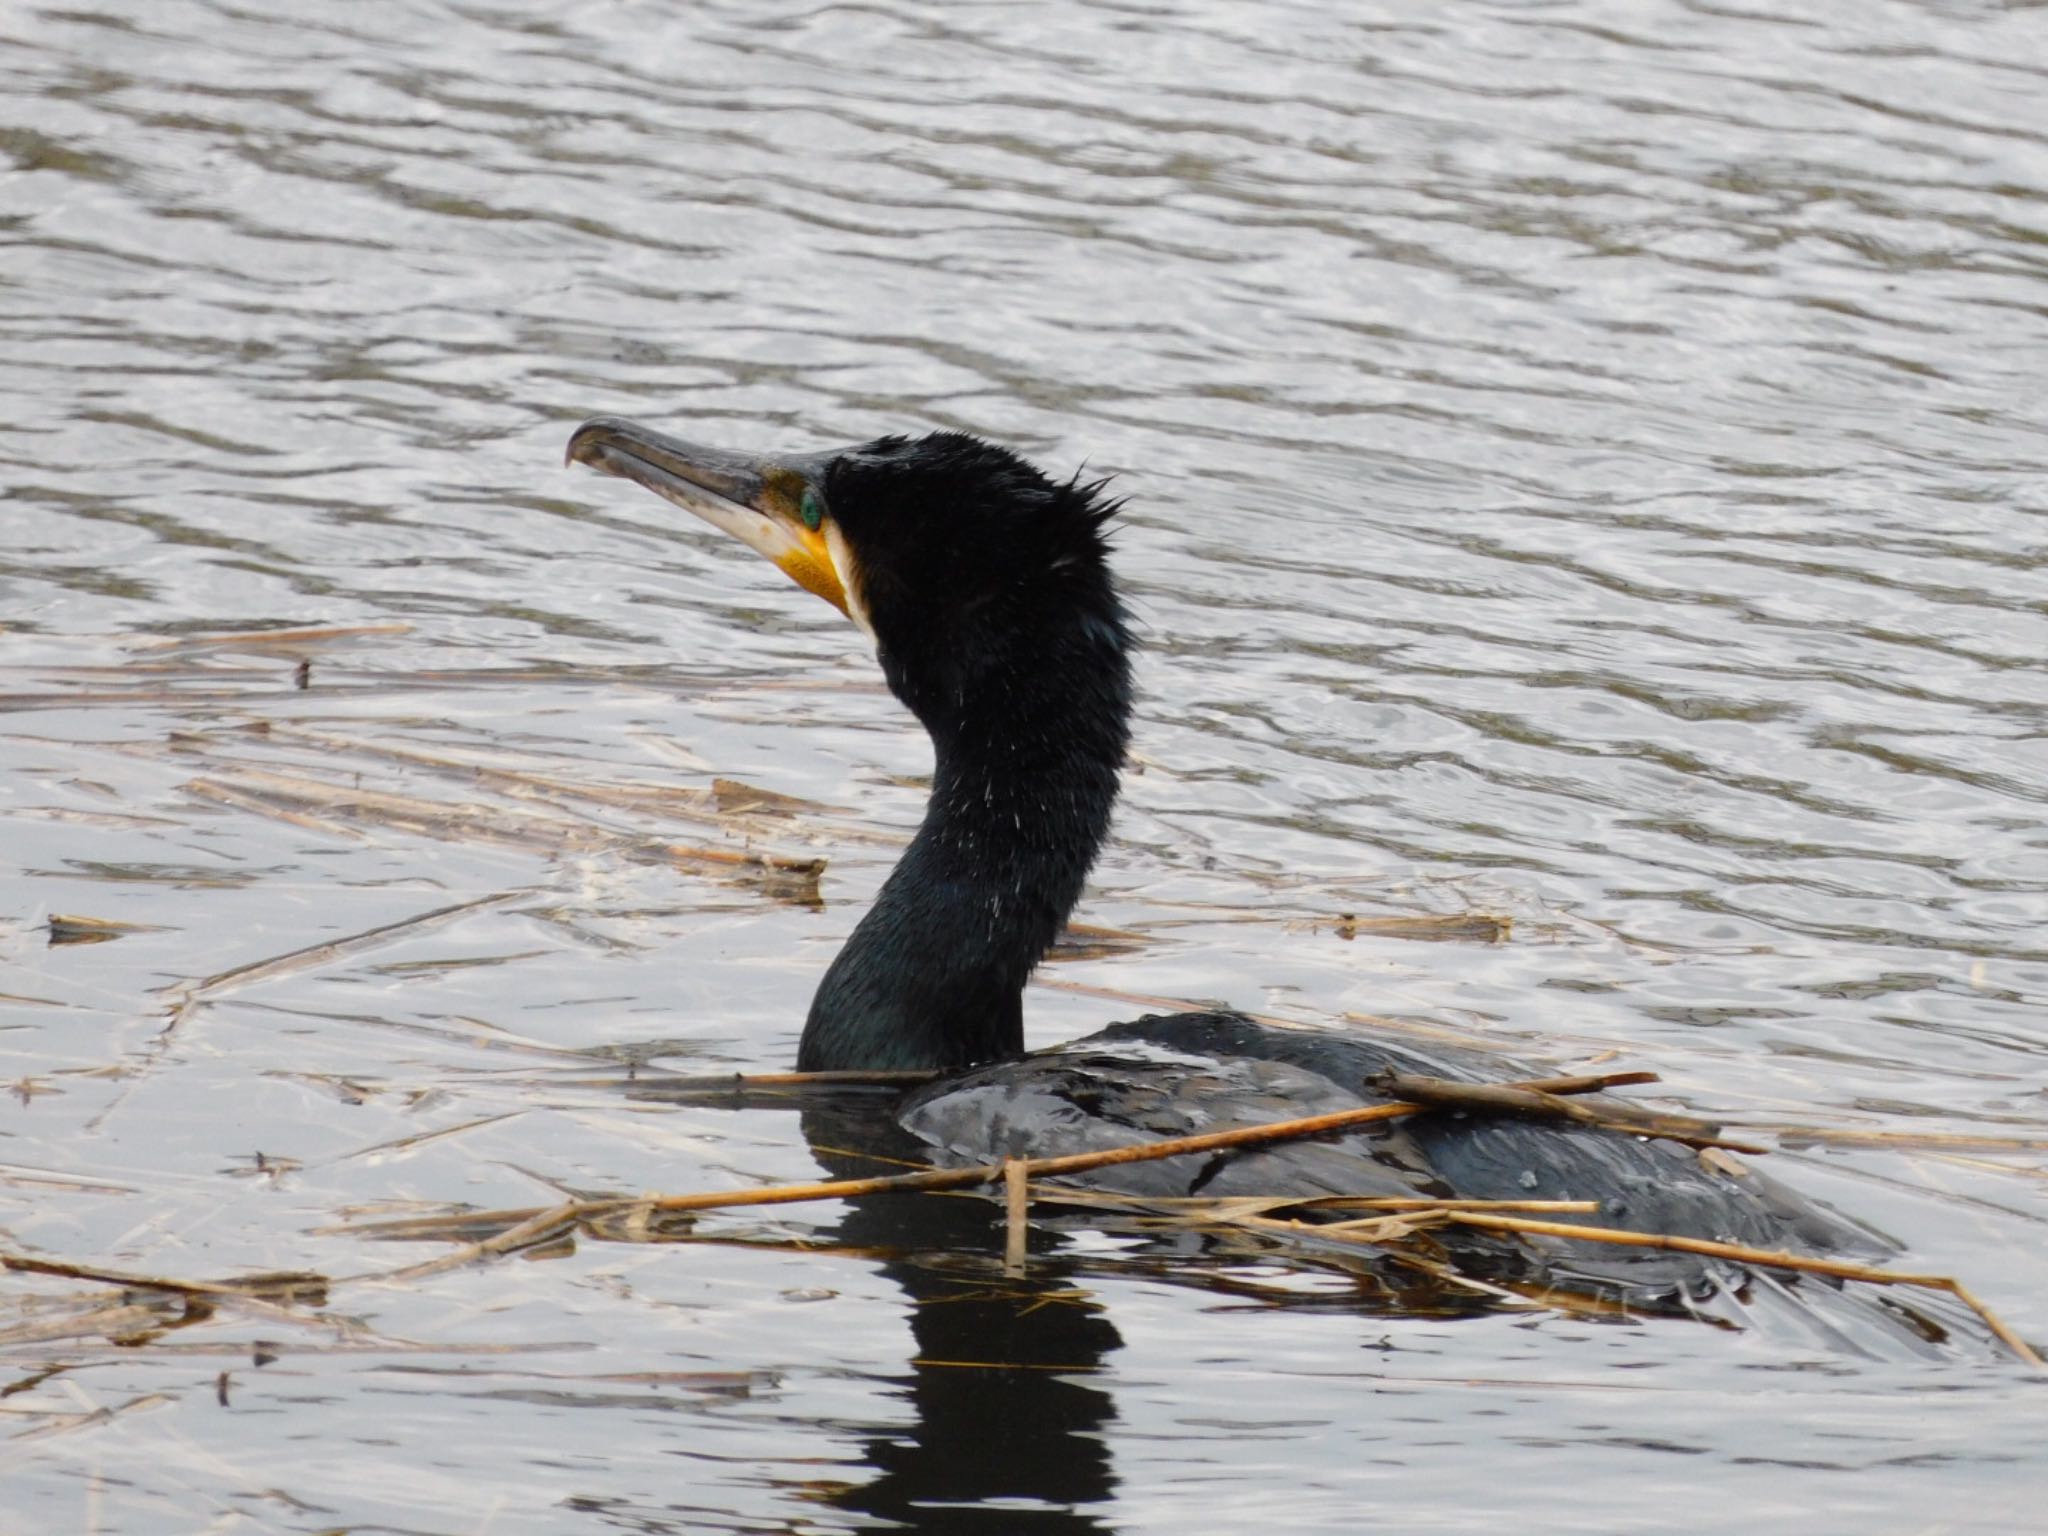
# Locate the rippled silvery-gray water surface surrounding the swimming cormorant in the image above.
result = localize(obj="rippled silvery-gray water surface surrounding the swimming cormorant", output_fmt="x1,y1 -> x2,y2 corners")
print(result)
0,0 -> 2048,1534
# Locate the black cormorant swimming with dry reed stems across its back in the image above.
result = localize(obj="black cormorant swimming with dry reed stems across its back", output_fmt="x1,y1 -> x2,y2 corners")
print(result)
567,418 -> 1870,1305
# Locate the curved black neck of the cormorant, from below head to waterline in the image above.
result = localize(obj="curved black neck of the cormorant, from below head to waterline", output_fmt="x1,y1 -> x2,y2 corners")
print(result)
797,610 -> 1130,1071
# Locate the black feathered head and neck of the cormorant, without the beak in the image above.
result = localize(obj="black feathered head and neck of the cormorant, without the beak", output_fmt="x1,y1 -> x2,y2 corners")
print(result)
797,432 -> 1130,1071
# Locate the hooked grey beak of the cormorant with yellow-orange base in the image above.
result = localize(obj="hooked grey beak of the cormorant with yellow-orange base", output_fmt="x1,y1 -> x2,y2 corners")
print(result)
567,416 -> 852,616
